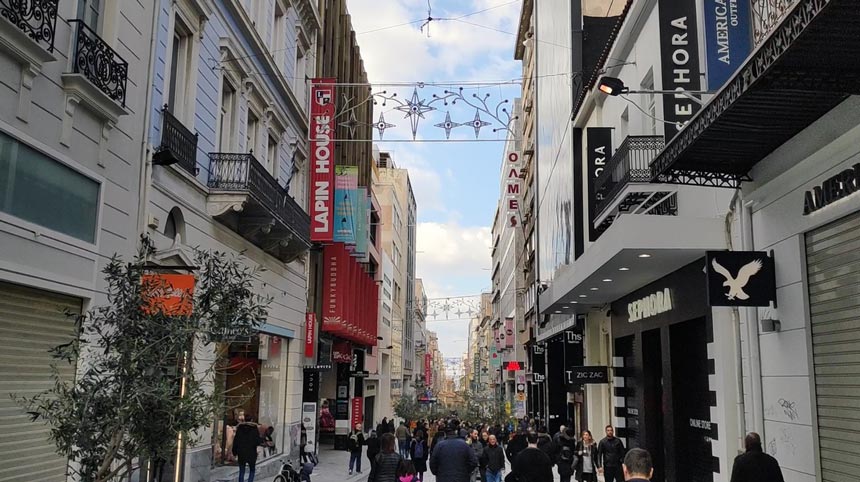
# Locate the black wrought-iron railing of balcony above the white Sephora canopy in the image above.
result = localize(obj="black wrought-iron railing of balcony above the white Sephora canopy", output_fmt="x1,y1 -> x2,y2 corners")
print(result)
594,136 -> 664,214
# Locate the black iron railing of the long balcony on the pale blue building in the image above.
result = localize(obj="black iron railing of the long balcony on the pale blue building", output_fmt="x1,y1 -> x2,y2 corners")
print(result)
209,152 -> 311,252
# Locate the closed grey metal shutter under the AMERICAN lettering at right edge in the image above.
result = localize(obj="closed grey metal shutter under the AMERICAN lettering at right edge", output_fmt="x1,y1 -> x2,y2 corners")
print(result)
806,215 -> 860,482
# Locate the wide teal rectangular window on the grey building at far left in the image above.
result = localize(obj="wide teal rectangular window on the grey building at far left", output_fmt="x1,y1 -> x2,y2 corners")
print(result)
0,132 -> 99,243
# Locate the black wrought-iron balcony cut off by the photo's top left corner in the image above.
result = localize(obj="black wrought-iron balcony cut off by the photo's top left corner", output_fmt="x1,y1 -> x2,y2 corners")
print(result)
0,0 -> 59,66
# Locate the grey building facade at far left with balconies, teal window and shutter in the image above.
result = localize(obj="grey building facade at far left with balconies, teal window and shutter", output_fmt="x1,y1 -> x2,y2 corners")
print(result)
0,0 -> 156,481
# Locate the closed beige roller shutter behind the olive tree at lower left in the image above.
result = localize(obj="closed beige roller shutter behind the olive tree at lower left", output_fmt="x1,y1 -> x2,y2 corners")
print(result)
0,283 -> 81,482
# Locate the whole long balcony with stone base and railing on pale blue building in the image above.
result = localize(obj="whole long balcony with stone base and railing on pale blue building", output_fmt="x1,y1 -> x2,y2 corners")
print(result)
206,152 -> 311,263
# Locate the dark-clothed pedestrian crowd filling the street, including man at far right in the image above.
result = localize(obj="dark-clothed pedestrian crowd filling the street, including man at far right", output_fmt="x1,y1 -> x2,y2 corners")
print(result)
340,417 -> 784,482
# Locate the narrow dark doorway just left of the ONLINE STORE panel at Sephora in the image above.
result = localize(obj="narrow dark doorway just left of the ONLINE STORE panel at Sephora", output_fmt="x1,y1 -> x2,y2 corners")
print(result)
640,328 -> 668,480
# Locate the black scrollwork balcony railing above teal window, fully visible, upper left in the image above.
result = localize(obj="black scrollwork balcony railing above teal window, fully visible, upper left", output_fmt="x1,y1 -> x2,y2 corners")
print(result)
69,20 -> 128,107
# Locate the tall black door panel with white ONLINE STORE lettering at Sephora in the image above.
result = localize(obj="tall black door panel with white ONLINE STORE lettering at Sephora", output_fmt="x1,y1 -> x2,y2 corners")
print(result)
669,319 -> 714,482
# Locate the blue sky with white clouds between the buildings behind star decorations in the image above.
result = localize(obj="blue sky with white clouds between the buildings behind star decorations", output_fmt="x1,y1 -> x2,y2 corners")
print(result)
347,0 -> 522,357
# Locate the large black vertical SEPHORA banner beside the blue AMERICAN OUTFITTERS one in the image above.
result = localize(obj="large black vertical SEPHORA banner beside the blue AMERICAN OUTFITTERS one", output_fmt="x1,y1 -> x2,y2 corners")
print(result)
659,0 -> 702,142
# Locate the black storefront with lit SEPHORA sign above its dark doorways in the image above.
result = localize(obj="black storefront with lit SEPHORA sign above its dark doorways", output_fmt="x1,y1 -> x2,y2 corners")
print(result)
612,264 -> 719,482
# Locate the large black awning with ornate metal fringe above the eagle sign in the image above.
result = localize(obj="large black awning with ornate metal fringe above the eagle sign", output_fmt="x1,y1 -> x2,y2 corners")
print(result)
651,0 -> 860,187
